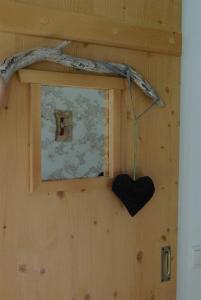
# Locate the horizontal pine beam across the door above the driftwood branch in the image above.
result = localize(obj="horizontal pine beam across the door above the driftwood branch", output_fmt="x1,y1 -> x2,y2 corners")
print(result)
0,0 -> 181,56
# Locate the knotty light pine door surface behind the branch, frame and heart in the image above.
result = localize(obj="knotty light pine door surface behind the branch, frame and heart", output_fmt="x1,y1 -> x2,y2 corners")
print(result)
0,0 -> 180,300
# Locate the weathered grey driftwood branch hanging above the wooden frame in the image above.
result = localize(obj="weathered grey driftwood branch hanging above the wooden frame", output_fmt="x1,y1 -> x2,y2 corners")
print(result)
0,41 -> 164,107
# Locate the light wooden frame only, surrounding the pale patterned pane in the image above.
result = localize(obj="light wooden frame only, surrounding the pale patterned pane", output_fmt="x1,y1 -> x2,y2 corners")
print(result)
19,69 -> 132,192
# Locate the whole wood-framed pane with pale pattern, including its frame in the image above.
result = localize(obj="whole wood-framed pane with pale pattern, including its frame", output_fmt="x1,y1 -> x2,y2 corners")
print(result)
19,70 -> 131,192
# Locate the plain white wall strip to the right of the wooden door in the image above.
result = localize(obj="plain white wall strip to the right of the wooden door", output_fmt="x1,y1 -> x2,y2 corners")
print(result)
177,0 -> 201,300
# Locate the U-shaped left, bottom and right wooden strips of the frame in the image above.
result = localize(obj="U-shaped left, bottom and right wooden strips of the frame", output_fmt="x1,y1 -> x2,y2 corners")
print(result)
30,81 -> 123,192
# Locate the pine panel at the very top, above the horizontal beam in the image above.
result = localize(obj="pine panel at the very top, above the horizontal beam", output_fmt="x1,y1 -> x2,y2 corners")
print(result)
10,0 -> 182,31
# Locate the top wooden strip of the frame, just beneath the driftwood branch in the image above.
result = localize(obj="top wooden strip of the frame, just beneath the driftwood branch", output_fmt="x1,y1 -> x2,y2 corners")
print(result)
18,69 -> 127,90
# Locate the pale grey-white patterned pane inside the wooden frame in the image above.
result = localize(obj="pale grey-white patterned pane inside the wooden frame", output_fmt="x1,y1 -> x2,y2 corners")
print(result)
41,86 -> 107,180
